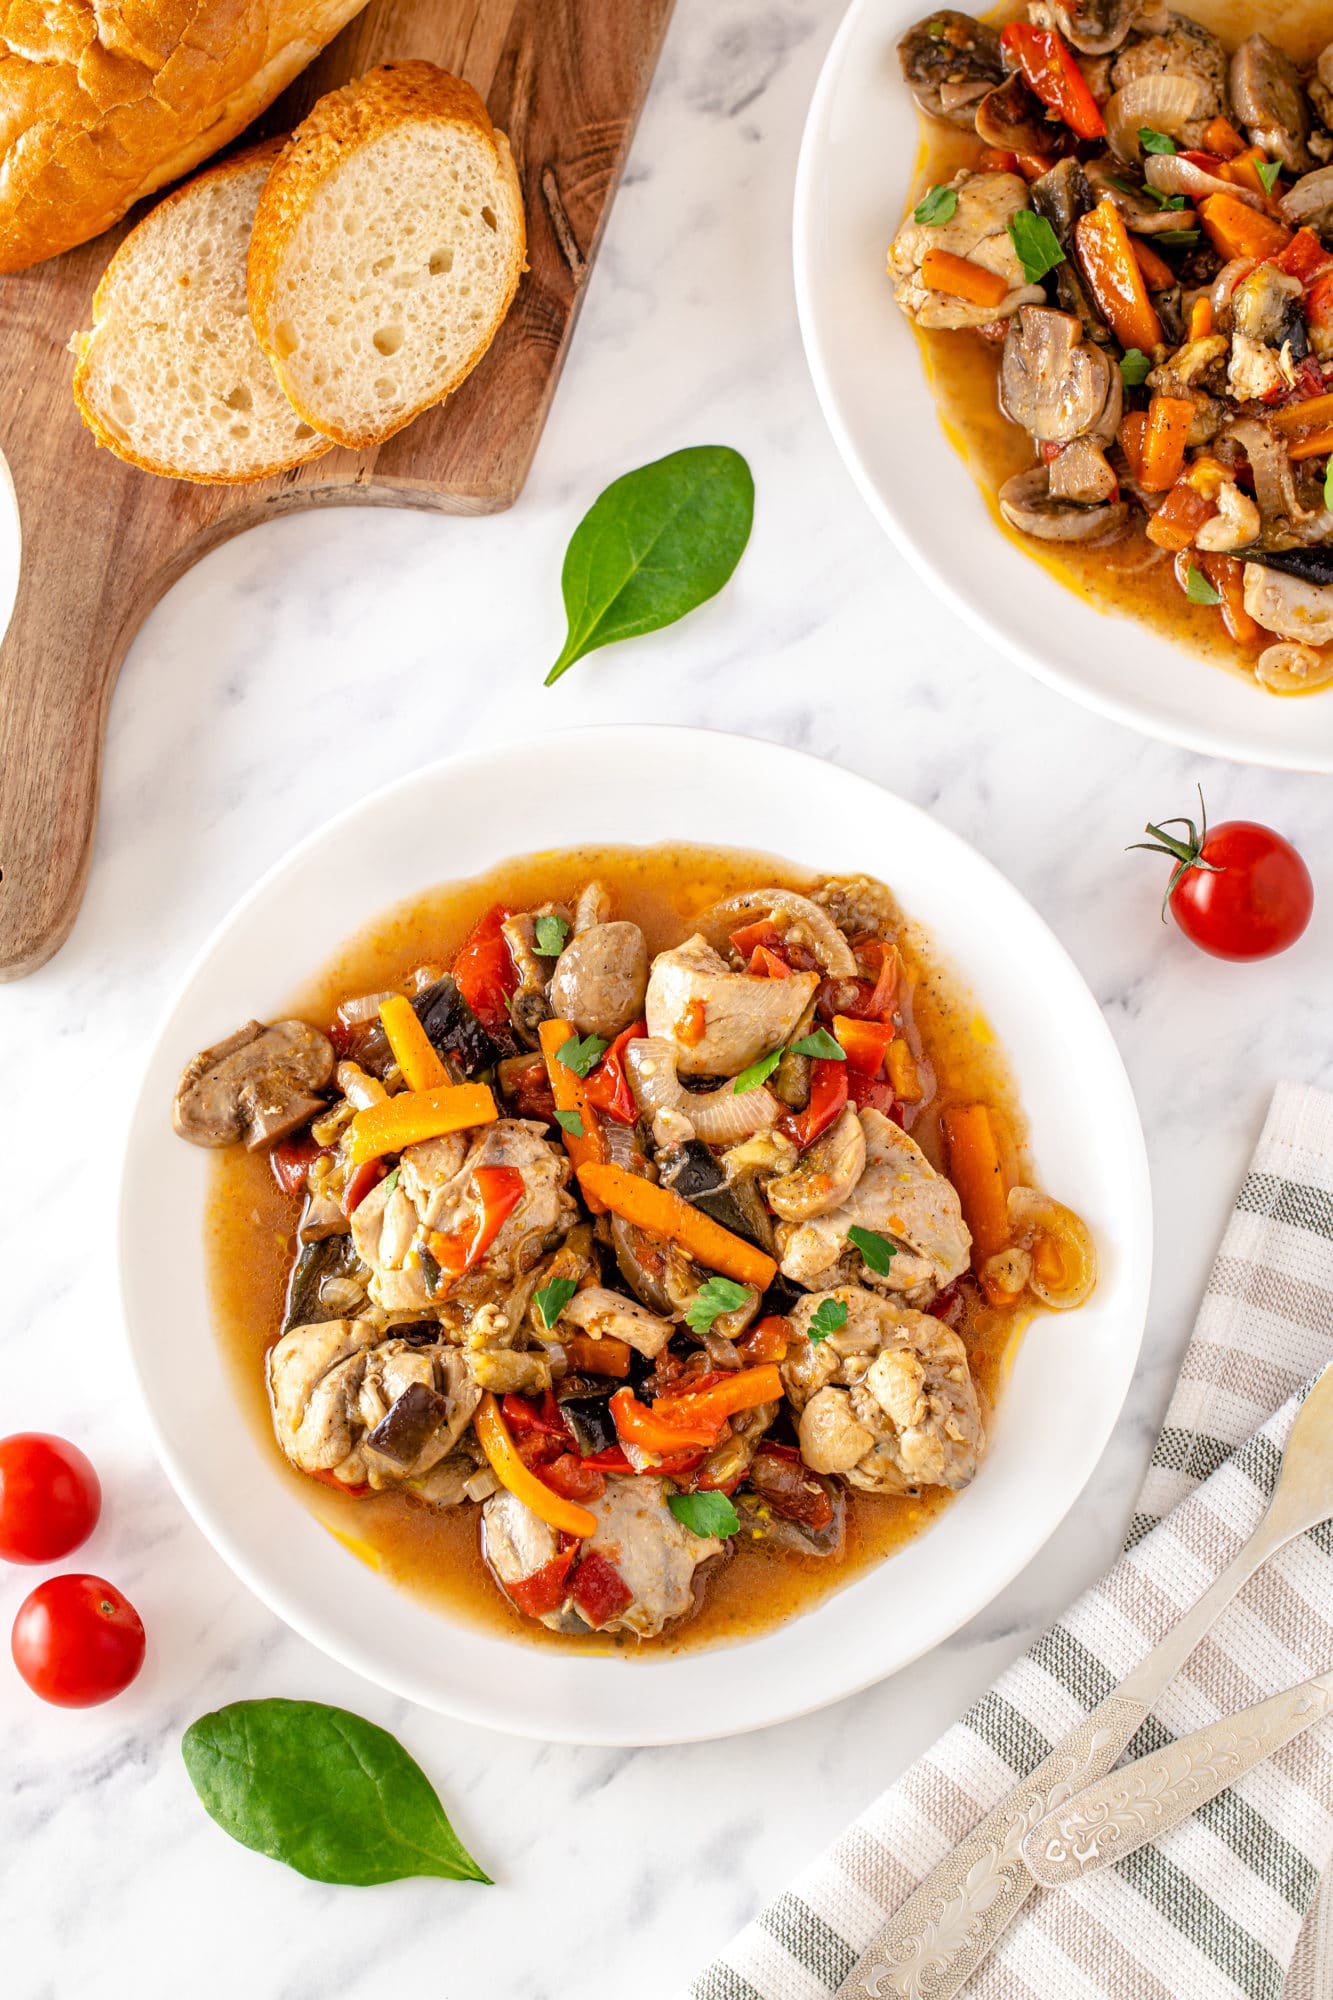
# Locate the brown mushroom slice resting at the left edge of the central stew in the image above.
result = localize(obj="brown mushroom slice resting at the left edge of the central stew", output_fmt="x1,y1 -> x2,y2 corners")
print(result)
172,1020 -> 334,1150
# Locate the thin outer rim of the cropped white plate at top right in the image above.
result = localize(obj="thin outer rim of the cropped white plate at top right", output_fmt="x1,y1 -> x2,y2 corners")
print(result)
791,0 -> 1333,776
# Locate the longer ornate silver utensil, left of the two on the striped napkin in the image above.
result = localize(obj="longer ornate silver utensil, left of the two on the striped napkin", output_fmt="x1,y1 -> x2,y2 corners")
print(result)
837,1366 -> 1333,2000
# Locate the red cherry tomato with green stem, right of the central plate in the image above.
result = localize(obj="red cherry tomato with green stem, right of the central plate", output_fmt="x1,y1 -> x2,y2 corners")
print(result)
1137,794 -> 1315,958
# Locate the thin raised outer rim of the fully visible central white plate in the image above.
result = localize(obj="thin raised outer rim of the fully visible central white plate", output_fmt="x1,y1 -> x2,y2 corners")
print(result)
116,722 -> 1153,1748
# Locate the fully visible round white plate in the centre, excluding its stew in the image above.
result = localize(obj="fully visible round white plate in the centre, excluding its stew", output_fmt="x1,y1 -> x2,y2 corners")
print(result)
120,728 -> 1151,1744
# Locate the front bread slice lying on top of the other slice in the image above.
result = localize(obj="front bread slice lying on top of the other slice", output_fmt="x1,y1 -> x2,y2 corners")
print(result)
250,62 -> 526,446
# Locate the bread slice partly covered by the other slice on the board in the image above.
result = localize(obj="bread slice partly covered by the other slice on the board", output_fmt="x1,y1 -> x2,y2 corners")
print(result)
70,140 -> 330,484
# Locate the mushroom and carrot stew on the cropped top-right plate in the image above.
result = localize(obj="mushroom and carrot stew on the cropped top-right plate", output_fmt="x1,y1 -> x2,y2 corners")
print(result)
889,0 -> 1333,694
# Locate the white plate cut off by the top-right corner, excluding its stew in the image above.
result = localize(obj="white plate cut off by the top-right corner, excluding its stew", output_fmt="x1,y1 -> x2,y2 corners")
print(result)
795,0 -> 1333,770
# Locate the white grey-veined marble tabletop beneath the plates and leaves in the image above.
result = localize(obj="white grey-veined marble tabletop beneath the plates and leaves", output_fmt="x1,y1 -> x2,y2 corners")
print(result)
0,0 -> 1333,2000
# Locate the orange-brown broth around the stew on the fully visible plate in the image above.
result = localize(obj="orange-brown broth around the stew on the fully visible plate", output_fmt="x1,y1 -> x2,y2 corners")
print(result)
204,846 -> 1031,1654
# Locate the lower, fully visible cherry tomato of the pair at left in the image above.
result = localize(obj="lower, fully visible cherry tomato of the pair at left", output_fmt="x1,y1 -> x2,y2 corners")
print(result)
10,1576 -> 144,1708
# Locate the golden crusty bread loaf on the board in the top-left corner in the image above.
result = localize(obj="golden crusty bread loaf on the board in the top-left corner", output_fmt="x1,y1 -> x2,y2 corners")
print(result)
0,0 -> 366,272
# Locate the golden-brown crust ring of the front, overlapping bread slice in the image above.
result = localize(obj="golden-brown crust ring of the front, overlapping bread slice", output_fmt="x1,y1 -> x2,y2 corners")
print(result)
246,62 -> 526,450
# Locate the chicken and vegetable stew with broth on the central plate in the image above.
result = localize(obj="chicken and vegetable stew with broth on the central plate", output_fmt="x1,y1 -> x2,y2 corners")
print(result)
192,848 -> 1095,1648
